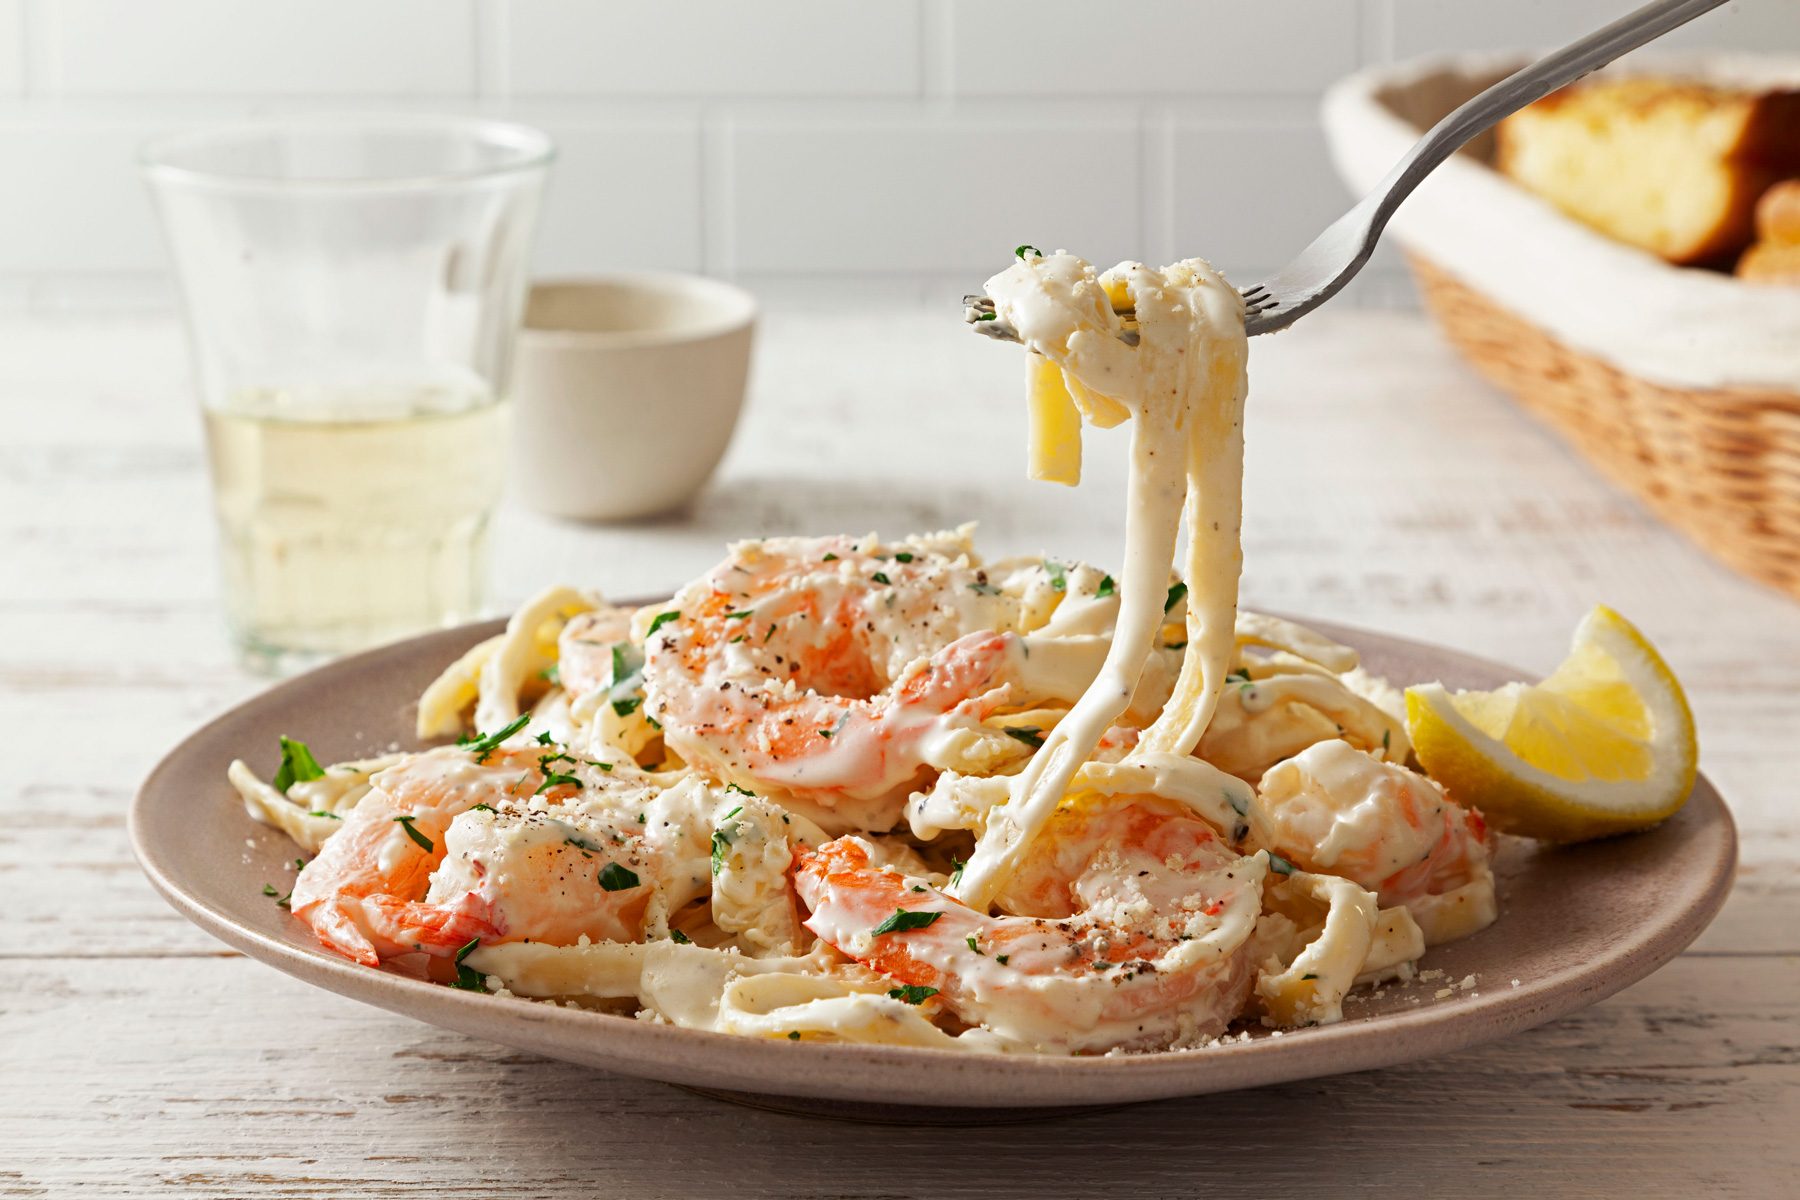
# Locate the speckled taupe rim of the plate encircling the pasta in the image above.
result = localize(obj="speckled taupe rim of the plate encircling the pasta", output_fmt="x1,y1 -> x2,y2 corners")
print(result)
130,621 -> 1737,1108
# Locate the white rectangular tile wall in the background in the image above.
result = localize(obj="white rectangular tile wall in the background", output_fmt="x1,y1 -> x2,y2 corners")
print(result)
0,0 -> 1800,306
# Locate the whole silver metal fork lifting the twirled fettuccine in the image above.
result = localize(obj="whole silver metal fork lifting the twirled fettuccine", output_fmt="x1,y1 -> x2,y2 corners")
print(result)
963,0 -> 1726,345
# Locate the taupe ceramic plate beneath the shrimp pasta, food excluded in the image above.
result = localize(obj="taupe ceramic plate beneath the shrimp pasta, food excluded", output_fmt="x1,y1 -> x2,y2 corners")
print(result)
131,622 -> 1737,1115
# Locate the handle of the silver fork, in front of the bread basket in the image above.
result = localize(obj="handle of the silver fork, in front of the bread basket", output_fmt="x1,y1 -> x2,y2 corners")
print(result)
1370,0 -> 1726,233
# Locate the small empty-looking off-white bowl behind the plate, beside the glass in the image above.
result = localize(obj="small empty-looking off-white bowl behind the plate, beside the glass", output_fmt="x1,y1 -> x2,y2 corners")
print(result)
513,273 -> 756,520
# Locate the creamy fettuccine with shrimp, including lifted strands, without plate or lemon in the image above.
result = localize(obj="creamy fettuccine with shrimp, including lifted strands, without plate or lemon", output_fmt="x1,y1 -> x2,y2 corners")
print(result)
230,246 -> 1496,1054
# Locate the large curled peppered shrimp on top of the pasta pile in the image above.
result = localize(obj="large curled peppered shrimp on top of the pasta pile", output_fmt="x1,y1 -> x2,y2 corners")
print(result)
644,538 -> 1051,831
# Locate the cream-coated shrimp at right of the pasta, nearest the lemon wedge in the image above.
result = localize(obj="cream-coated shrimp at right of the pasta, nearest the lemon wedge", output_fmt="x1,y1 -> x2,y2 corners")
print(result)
1253,741 -> 1492,941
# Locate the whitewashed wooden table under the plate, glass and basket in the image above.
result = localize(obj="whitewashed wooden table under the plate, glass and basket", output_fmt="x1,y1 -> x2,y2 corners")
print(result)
0,309 -> 1800,1200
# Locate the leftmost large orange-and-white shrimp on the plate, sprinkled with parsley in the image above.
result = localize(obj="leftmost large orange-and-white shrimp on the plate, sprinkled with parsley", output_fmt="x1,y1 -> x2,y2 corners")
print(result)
290,747 -> 669,966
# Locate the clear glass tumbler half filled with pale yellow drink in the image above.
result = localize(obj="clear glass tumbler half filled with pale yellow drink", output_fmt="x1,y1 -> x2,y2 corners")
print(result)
142,117 -> 553,671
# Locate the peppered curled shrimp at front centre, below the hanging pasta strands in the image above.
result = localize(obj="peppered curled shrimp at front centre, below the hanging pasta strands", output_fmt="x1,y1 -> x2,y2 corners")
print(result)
794,797 -> 1267,1052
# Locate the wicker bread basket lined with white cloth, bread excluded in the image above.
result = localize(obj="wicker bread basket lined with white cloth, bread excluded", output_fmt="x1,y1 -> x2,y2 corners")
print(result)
1327,59 -> 1800,597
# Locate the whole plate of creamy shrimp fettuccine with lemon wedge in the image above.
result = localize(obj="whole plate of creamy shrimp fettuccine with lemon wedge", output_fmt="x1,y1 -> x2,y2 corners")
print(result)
133,246 -> 1735,1114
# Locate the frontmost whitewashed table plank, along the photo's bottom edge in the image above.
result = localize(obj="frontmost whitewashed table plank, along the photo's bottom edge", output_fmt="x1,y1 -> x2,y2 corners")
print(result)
0,955 -> 1800,1200
